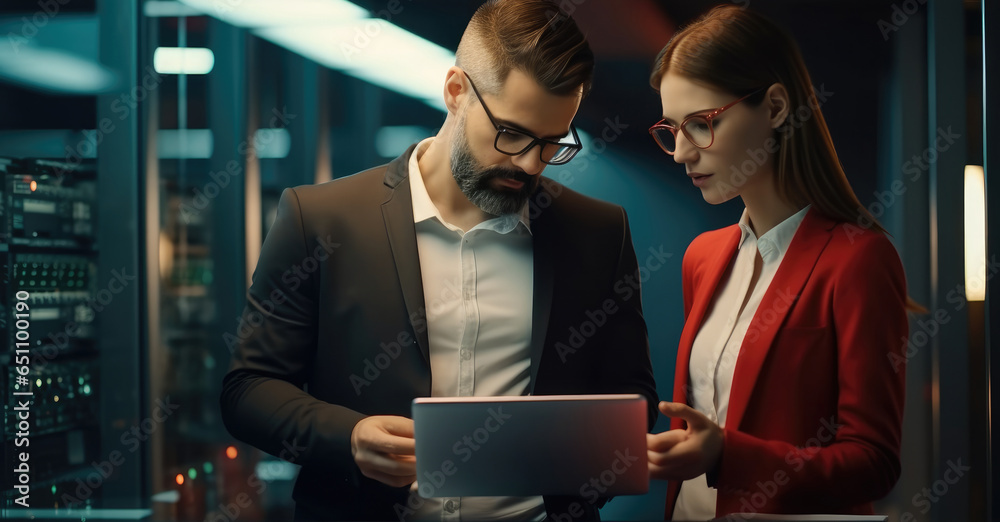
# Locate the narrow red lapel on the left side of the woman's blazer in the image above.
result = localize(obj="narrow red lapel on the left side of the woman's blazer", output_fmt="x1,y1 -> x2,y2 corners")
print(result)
671,226 -> 740,420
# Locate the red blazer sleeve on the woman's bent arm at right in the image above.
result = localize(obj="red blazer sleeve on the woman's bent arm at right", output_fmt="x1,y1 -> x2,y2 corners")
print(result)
715,236 -> 909,506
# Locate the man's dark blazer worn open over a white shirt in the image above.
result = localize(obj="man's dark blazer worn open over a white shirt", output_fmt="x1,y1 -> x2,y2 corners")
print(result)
220,146 -> 657,520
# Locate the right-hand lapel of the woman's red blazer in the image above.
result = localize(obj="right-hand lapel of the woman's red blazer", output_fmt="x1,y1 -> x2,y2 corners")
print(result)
726,209 -> 835,429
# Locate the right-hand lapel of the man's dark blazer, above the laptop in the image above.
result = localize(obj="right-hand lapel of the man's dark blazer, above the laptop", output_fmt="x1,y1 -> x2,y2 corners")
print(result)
528,178 -> 555,394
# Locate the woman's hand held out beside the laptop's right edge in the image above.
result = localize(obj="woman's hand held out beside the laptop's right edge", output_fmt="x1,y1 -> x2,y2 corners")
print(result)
646,402 -> 723,480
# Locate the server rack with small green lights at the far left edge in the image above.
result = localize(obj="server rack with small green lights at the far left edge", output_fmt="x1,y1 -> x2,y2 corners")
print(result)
0,159 -> 104,508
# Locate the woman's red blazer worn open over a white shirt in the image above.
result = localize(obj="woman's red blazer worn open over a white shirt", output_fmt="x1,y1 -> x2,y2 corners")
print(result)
666,208 -> 909,519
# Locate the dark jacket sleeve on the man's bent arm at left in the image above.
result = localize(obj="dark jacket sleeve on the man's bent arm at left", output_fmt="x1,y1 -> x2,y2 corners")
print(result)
220,189 -> 364,481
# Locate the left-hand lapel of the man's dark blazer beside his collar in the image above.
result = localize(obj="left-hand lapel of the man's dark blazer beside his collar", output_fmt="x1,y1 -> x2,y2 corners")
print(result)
382,145 -> 430,364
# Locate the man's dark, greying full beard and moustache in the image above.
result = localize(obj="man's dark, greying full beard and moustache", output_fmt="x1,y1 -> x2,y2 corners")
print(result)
451,118 -> 541,216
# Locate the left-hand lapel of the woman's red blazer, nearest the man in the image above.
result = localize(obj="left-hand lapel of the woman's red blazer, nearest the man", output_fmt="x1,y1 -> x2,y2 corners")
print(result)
670,226 -> 740,429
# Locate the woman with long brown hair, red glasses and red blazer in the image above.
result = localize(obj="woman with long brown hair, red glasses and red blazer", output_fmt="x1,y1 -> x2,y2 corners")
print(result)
648,5 -> 920,520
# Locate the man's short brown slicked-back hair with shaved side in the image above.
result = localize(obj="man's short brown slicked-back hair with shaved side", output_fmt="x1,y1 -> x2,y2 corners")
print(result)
455,0 -> 594,96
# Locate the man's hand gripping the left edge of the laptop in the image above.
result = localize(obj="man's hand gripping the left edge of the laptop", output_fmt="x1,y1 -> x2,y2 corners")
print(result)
351,415 -> 417,488
